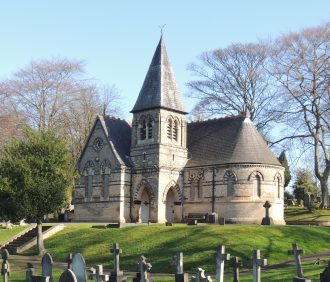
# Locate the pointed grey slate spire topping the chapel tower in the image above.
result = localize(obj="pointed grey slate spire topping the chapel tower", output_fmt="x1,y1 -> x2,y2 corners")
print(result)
131,36 -> 186,114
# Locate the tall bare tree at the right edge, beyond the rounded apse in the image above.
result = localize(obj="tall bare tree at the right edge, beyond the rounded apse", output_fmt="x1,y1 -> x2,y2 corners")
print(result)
272,23 -> 330,208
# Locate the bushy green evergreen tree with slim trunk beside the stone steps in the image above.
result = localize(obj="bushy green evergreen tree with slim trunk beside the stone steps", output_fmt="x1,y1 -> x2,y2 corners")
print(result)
0,130 -> 74,254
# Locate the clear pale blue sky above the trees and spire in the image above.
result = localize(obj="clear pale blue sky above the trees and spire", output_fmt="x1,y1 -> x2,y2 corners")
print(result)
0,0 -> 330,119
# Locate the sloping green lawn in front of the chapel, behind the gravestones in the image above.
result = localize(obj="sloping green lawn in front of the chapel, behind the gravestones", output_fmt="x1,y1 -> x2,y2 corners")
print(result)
23,224 -> 330,273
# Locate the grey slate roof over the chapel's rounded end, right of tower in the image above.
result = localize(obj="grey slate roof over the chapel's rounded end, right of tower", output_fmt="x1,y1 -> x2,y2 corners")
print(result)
187,115 -> 281,167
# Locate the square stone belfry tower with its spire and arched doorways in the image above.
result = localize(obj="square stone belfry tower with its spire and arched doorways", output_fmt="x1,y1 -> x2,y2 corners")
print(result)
130,37 -> 187,222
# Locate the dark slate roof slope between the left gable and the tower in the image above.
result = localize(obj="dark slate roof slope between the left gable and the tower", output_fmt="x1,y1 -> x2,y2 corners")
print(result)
100,116 -> 132,166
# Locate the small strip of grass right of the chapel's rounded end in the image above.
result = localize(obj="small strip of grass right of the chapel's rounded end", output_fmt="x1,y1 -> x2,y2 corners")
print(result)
284,207 -> 330,221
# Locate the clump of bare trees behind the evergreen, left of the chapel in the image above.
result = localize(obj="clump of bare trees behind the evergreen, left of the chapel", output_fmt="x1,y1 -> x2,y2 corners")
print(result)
0,58 -> 120,163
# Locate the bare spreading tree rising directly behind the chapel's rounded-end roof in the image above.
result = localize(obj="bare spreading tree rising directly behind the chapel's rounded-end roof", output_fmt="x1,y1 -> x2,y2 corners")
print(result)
188,44 -> 278,133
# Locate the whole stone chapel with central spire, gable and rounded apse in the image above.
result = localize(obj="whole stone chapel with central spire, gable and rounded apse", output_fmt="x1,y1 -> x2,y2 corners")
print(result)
74,37 -> 285,224
